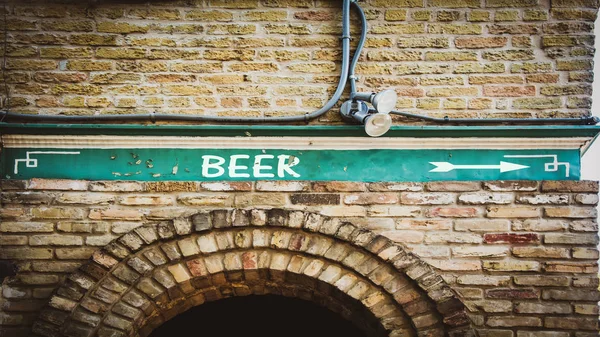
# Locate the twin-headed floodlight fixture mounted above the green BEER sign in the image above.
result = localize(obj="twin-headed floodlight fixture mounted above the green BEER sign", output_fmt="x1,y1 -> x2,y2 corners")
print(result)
341,100 -> 395,137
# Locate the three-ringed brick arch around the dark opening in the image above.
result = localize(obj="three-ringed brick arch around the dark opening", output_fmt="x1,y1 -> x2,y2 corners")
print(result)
33,209 -> 474,337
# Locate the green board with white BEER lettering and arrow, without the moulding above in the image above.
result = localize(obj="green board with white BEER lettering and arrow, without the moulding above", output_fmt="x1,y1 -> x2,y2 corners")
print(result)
1,148 -> 580,182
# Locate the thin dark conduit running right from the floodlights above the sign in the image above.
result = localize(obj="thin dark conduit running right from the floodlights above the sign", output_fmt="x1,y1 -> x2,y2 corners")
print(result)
386,109 -> 600,125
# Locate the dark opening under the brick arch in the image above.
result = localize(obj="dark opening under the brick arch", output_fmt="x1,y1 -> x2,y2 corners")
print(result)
150,295 -> 367,337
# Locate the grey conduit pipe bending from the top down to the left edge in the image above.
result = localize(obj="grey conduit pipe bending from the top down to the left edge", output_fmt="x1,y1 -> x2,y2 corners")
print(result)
0,0 -> 358,124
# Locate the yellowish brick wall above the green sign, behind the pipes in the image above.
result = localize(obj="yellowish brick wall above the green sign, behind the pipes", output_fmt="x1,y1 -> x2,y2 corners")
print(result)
0,0 -> 597,122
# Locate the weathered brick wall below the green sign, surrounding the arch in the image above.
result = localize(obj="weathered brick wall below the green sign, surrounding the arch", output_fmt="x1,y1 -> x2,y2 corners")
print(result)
0,179 -> 600,337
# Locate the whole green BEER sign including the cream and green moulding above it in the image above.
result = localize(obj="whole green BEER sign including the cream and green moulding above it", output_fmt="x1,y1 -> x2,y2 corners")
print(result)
0,125 -> 598,182
